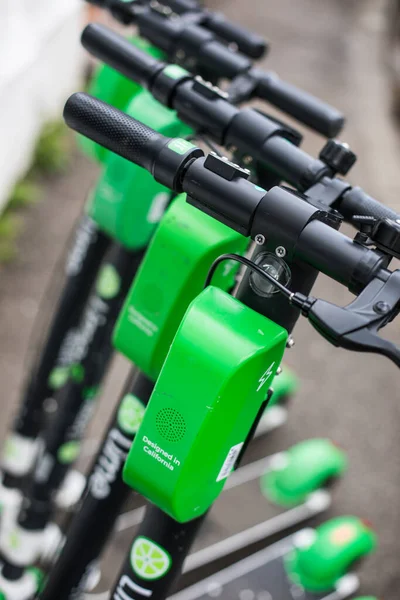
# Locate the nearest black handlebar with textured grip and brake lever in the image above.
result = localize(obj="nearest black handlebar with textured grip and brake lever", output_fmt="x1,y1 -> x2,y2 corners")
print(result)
64,94 -> 400,366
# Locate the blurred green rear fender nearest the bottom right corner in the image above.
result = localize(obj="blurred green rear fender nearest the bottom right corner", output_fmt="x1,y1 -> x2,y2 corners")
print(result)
286,516 -> 377,592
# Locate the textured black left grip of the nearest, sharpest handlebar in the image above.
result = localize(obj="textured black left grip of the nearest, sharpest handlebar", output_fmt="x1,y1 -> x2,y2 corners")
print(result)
64,93 -> 170,172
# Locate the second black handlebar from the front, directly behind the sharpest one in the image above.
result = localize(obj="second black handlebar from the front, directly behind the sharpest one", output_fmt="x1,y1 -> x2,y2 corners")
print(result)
82,25 -> 399,221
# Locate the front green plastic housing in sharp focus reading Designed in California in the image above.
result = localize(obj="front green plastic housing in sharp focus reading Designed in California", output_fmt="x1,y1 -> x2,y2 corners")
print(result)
124,286 -> 287,522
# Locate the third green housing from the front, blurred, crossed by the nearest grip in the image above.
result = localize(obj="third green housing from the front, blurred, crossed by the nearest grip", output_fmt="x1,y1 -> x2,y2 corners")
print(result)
87,90 -> 192,250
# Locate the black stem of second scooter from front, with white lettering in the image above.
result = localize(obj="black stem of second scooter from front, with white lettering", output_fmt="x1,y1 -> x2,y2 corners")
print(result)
39,372 -> 154,600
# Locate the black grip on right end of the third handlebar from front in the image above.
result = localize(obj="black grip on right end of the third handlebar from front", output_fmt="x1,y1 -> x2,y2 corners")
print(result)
256,70 -> 344,138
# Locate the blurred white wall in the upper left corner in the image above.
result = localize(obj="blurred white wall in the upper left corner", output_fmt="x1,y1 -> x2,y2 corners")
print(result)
0,0 -> 84,211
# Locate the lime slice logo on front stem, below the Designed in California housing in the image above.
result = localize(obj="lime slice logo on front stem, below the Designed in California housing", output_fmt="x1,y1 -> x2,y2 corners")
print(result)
131,536 -> 172,580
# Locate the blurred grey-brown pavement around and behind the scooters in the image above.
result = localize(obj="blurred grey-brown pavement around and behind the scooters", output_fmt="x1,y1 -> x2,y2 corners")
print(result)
0,0 -> 400,600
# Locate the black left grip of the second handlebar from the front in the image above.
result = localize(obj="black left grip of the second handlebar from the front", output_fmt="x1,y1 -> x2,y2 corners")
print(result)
81,23 -> 163,87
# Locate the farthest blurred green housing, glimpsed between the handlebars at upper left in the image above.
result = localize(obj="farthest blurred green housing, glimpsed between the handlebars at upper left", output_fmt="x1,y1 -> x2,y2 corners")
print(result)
78,37 -> 165,163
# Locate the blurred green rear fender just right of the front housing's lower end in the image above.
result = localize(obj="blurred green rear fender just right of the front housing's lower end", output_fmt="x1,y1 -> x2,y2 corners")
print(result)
260,439 -> 347,506
